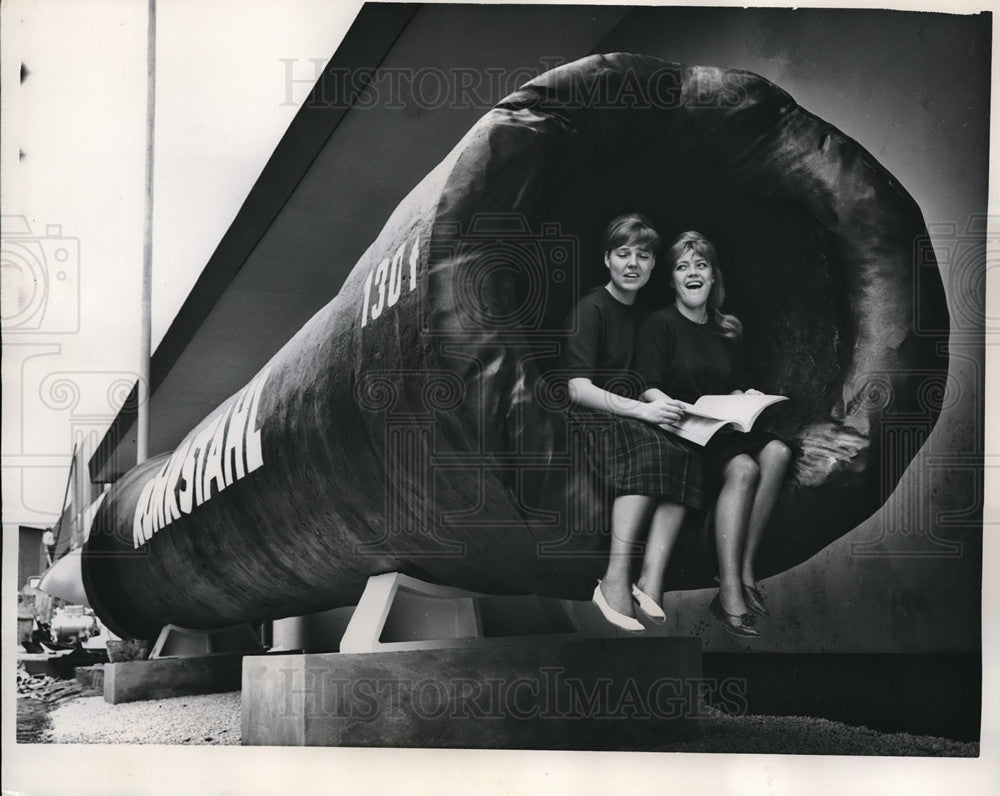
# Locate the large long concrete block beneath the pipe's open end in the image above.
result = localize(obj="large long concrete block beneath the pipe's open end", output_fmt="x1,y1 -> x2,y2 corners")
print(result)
242,638 -> 705,750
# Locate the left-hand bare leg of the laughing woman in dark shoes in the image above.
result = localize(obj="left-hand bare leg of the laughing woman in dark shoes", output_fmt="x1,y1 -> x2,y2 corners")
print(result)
715,453 -> 760,616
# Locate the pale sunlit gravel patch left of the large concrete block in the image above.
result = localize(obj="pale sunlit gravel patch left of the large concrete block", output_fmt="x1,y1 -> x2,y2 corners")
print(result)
44,691 -> 240,746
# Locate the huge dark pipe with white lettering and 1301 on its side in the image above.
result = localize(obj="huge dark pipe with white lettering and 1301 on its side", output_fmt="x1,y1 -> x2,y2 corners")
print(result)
84,54 -> 948,636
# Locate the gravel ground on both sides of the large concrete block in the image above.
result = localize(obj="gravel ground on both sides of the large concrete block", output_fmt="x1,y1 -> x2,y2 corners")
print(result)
40,691 -> 979,757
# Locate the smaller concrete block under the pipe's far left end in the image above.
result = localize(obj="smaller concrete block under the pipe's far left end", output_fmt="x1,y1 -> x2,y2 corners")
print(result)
104,655 -> 243,704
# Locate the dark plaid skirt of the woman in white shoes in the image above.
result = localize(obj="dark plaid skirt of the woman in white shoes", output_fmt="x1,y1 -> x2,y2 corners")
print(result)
572,411 -> 707,509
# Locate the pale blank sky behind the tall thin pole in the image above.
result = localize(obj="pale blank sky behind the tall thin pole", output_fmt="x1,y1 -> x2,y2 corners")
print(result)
0,0 -> 361,526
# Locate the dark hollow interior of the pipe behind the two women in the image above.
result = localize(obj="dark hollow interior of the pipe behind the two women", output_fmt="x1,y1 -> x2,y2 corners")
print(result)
500,146 -> 853,442
